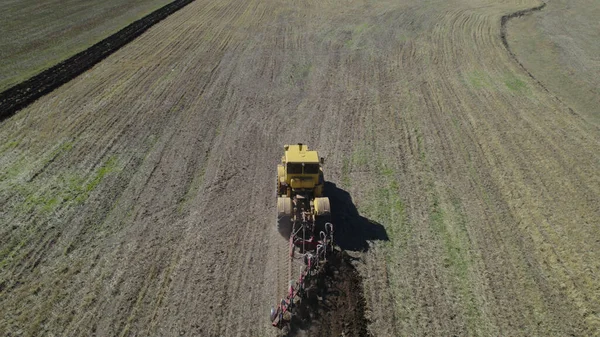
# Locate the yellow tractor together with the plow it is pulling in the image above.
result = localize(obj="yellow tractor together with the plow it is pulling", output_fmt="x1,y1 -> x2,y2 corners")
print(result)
271,144 -> 334,328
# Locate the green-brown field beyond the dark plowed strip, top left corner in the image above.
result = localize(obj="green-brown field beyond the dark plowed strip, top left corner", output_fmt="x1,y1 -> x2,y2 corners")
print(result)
0,0 -> 169,91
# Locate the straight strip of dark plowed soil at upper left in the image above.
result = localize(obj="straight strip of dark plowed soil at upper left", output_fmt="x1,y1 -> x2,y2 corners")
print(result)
0,0 -> 194,122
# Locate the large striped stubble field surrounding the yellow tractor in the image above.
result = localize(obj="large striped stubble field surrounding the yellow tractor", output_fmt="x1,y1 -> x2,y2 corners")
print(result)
0,0 -> 600,336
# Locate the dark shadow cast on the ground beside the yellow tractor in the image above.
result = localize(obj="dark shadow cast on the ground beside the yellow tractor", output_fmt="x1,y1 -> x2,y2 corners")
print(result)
325,182 -> 389,252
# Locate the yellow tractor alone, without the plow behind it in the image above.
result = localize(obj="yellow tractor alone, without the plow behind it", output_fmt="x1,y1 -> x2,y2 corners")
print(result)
277,143 -> 331,238
